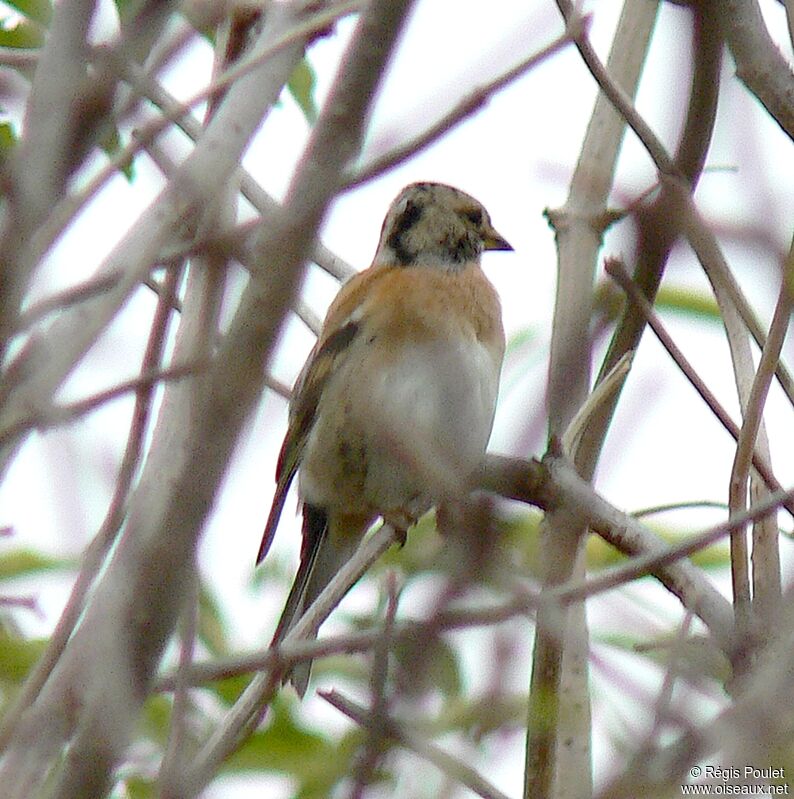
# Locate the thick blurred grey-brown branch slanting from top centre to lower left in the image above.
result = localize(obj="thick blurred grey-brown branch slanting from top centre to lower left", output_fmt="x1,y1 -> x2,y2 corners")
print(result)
50,0 -> 410,796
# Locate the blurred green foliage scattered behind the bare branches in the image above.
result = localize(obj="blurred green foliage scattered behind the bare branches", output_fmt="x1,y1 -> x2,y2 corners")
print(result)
0,0 -> 768,799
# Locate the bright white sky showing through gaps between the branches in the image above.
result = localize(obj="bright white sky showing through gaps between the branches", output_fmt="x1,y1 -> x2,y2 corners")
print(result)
0,0 -> 794,797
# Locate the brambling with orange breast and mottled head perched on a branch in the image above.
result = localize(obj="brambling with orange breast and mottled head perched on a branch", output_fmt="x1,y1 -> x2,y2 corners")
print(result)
257,183 -> 513,696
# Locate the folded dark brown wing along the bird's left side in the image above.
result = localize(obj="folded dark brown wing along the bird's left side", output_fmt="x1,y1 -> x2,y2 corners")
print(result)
256,322 -> 359,565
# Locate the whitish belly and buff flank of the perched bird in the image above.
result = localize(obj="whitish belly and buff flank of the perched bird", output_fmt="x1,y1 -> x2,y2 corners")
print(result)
300,332 -> 501,516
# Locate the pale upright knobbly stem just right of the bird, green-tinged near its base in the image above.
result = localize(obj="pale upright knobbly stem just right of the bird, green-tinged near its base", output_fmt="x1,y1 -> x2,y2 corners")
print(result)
524,0 -> 656,799
